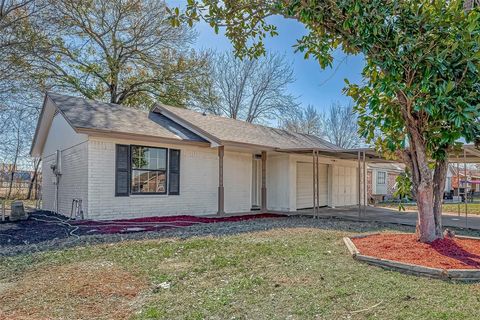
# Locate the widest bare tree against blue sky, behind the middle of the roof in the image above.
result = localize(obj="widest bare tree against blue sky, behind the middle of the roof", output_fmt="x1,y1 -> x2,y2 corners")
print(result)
204,53 -> 298,122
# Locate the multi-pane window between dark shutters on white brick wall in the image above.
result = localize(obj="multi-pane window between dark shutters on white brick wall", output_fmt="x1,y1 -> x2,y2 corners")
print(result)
130,146 -> 167,194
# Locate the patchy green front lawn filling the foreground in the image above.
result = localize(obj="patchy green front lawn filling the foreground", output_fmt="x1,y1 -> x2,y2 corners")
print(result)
0,224 -> 480,319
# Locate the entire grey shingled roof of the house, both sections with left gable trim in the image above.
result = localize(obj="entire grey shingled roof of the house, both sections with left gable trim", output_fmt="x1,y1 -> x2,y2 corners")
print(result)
31,92 -> 343,155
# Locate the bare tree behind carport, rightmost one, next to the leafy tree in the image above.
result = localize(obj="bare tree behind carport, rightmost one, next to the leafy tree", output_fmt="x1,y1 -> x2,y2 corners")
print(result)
321,103 -> 362,149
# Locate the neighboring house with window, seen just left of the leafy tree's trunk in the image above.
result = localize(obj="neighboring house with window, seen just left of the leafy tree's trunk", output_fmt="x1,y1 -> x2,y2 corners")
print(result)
367,163 -> 405,203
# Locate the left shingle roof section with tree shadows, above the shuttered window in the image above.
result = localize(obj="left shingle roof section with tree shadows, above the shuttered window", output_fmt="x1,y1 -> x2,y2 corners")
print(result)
47,93 -> 206,142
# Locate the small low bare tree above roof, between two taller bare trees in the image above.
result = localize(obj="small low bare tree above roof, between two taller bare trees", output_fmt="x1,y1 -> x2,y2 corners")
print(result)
281,105 -> 322,136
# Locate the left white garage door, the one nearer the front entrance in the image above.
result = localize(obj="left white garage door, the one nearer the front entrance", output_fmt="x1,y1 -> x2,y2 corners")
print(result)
297,162 -> 328,209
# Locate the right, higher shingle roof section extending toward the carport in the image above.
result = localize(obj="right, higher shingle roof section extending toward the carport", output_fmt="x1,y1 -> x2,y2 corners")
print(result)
154,105 -> 342,150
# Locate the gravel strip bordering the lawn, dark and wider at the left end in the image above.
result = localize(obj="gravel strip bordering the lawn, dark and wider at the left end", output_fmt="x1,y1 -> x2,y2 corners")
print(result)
0,212 -> 480,256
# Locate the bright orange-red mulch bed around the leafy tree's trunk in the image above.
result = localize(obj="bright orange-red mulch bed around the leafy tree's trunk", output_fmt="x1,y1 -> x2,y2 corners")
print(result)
352,234 -> 480,269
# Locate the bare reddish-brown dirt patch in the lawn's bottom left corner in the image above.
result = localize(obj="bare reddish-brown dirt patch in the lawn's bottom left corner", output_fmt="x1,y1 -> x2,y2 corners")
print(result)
0,261 -> 146,319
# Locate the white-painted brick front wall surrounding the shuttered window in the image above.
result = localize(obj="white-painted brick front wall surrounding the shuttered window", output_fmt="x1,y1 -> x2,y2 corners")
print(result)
88,140 -> 252,219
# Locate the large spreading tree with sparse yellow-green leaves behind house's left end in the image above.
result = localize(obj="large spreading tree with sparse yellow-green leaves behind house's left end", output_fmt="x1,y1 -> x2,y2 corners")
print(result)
16,0 -> 208,107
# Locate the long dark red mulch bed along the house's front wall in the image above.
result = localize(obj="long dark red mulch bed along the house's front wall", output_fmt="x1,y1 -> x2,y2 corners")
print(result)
70,213 -> 284,234
